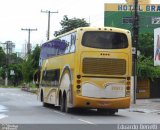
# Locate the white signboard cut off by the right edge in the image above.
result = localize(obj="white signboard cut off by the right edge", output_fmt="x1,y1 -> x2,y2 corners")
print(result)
154,28 -> 160,66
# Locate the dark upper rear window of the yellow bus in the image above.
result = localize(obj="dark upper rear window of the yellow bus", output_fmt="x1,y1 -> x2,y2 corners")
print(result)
82,31 -> 128,49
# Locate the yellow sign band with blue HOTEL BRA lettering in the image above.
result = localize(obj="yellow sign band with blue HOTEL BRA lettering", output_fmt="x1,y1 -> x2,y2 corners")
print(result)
105,4 -> 160,12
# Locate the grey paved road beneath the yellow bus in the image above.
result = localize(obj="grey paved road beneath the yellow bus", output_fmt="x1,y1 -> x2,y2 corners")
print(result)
0,88 -> 160,125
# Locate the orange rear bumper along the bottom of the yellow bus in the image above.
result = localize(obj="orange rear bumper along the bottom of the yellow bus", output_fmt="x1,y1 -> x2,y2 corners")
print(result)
74,96 -> 130,109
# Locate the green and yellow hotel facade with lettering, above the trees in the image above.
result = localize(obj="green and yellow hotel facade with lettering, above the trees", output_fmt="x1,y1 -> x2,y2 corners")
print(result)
104,0 -> 160,33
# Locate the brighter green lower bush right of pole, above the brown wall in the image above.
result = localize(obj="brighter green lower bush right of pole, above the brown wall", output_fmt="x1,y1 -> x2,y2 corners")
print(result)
137,55 -> 160,80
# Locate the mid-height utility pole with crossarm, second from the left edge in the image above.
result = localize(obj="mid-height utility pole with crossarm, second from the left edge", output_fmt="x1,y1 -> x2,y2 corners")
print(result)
21,28 -> 37,54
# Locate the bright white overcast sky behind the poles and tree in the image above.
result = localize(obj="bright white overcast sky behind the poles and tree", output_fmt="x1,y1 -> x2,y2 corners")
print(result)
0,0 -> 160,52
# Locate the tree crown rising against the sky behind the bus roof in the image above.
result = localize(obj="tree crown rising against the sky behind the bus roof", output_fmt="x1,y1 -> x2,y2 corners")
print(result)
54,15 -> 89,36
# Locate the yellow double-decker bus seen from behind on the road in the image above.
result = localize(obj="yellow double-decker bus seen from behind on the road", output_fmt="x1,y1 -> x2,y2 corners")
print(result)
39,27 -> 132,114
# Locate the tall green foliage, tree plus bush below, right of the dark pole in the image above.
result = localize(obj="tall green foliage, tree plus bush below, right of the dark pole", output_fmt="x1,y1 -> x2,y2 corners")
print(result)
137,33 -> 160,80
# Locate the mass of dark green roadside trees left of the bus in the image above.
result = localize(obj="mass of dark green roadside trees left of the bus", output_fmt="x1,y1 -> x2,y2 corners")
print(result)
0,41 -> 40,85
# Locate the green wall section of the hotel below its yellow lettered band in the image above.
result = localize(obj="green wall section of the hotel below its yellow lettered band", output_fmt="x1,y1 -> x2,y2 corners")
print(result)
104,11 -> 160,33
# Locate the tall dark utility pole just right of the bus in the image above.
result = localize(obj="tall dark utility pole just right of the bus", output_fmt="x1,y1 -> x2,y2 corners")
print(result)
132,0 -> 139,104
